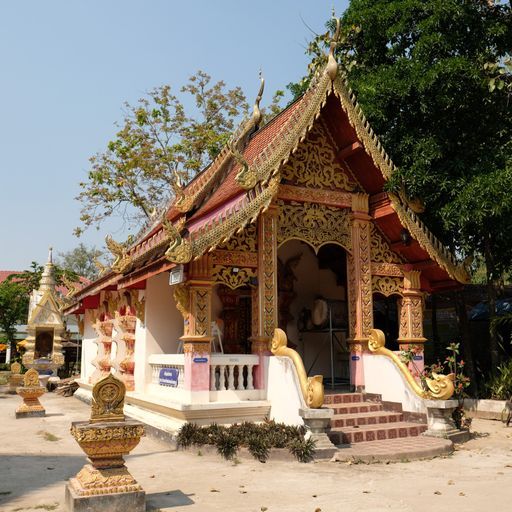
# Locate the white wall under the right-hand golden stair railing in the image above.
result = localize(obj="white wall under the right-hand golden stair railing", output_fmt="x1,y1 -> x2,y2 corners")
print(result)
363,354 -> 427,414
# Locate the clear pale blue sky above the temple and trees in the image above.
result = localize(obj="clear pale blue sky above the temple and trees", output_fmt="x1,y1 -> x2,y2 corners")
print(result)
0,0 -> 348,270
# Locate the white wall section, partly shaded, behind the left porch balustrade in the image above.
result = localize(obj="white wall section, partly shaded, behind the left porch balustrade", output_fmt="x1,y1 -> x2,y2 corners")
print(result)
134,272 -> 183,392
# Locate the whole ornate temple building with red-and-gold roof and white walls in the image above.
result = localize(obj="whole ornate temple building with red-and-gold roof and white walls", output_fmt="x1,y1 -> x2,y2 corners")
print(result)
66,38 -> 468,432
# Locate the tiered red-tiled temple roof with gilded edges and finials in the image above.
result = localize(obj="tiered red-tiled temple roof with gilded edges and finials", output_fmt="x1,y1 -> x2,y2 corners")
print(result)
65,39 -> 468,312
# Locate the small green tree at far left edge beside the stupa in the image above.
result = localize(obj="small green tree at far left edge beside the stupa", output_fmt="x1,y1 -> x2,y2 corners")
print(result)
0,279 -> 28,357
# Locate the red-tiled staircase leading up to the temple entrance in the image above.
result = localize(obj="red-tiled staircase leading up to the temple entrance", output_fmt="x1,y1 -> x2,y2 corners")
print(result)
324,393 -> 427,445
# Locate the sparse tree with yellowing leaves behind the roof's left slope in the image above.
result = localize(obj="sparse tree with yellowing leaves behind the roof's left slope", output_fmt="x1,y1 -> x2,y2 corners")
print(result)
75,71 -> 248,236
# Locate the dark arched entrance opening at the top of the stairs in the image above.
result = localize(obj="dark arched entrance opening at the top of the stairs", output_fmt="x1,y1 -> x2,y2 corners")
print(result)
278,239 -> 350,387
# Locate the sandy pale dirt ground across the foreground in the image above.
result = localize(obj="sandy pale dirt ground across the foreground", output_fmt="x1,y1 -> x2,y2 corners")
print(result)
0,391 -> 512,512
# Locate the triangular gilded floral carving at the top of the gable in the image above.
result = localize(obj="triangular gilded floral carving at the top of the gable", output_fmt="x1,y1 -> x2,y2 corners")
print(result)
281,122 -> 357,192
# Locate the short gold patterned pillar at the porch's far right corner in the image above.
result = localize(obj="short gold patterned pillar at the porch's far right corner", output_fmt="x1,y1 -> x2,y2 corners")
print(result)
398,270 -> 427,352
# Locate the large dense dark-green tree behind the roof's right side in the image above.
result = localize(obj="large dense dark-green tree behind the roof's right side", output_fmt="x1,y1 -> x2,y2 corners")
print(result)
289,0 -> 512,374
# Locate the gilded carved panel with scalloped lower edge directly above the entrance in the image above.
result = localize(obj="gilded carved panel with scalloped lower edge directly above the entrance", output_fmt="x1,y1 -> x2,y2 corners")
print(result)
277,201 -> 352,251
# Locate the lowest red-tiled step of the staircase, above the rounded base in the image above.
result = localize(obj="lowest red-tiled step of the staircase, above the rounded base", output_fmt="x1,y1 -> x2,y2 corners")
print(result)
329,421 -> 427,444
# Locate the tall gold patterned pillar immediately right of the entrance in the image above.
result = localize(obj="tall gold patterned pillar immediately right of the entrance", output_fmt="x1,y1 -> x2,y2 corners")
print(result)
347,194 -> 373,388
